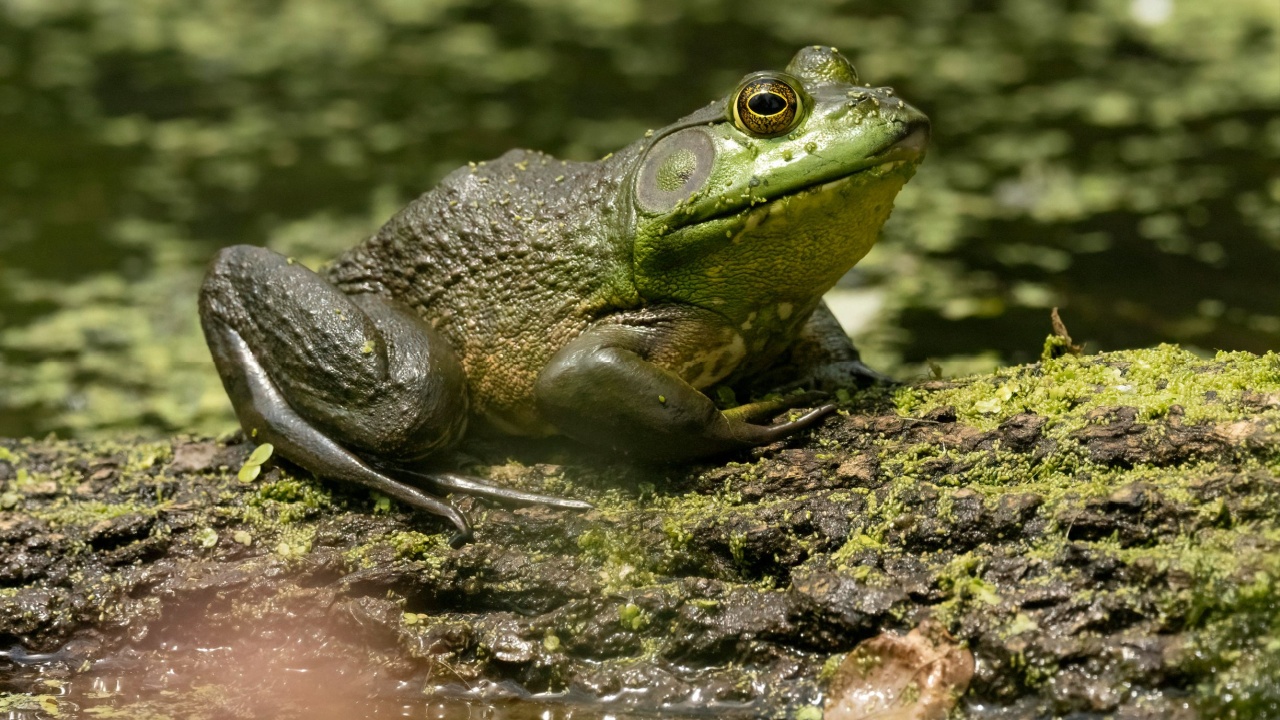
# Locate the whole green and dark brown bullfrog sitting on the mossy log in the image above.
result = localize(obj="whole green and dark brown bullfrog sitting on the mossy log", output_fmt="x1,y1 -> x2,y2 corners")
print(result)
200,46 -> 929,544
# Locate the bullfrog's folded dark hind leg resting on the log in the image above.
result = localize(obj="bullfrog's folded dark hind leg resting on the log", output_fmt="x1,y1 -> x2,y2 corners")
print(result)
200,246 -> 471,544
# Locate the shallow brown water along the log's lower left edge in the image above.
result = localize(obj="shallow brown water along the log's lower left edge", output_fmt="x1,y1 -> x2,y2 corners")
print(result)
0,637 -> 762,720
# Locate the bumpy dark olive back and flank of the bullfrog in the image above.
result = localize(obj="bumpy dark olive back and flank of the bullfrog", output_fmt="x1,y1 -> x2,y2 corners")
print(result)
328,150 -> 639,433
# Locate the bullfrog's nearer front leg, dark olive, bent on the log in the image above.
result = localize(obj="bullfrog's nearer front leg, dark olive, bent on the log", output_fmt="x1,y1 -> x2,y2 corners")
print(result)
535,302 -> 835,461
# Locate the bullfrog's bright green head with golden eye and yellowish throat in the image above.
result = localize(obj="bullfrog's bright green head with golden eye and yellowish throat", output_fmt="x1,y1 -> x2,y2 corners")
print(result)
626,47 -> 929,323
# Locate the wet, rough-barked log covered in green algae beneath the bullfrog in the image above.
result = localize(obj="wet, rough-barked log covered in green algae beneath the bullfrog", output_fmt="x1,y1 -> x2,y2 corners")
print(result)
0,347 -> 1280,717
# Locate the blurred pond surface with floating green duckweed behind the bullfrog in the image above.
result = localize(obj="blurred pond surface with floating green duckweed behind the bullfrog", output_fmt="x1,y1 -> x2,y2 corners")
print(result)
0,0 -> 1280,436
